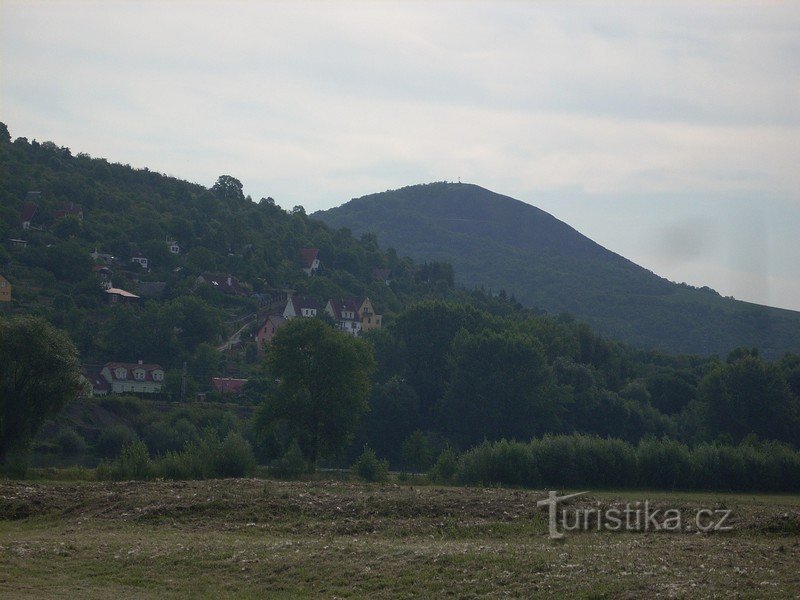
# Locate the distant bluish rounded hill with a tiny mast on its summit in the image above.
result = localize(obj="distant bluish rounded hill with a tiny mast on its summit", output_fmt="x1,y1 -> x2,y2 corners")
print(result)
312,183 -> 800,357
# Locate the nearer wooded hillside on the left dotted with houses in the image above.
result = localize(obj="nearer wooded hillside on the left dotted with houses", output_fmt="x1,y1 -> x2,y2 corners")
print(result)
0,124 -> 476,387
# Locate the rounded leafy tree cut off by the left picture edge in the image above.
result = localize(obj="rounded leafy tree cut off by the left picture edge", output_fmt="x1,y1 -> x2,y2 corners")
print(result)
0,316 -> 81,462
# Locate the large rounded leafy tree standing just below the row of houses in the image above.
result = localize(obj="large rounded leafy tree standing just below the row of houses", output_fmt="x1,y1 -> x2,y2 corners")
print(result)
257,318 -> 375,463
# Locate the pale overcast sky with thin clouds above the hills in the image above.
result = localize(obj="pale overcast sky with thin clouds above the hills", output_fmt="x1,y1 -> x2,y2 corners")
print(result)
0,0 -> 800,310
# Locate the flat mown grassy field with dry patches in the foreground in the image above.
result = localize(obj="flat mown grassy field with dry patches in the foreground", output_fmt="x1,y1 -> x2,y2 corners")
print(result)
0,479 -> 800,599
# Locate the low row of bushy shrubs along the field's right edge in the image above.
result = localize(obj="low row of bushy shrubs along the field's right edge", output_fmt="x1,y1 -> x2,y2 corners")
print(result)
432,435 -> 800,492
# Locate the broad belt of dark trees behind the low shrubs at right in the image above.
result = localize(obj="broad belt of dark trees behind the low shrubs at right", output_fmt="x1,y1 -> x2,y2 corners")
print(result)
354,301 -> 800,468
